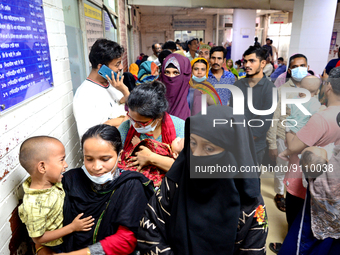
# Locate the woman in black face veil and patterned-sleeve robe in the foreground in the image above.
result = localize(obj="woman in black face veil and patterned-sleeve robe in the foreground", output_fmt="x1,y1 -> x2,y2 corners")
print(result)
137,105 -> 267,255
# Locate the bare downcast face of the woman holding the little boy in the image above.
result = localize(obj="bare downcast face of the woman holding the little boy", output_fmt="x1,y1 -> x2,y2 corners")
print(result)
83,137 -> 118,177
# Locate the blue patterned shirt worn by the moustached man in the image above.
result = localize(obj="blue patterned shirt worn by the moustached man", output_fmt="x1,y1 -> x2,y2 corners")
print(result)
207,67 -> 235,105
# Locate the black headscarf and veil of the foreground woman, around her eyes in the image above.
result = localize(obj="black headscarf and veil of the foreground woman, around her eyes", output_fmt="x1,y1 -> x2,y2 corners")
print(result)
166,105 -> 260,255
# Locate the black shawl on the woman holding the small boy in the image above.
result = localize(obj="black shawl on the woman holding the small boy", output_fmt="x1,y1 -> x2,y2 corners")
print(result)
62,168 -> 154,252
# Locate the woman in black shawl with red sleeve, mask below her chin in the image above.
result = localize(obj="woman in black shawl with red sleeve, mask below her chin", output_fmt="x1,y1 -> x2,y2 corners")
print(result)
41,125 -> 153,255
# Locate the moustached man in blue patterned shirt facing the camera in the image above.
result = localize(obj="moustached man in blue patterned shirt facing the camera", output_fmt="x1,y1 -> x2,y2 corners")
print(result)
207,46 -> 235,105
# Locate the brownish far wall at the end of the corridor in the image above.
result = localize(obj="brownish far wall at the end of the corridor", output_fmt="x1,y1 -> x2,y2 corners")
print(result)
141,15 -> 213,55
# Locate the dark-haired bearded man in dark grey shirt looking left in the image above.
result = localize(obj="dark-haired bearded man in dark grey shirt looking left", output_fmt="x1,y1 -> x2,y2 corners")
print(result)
230,46 -> 275,165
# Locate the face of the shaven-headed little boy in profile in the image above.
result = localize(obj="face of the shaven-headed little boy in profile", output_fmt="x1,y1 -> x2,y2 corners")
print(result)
45,141 -> 68,184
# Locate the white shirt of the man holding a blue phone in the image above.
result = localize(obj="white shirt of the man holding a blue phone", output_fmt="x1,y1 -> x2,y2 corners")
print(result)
73,79 -> 126,137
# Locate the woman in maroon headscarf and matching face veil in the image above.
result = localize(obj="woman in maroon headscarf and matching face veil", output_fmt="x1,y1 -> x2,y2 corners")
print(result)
160,53 -> 191,120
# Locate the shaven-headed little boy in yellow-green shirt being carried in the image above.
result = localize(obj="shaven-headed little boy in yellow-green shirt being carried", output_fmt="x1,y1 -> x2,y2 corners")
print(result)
19,136 -> 94,252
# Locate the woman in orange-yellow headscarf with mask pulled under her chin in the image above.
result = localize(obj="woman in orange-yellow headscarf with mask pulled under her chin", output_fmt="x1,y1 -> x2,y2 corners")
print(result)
188,58 -> 222,116
